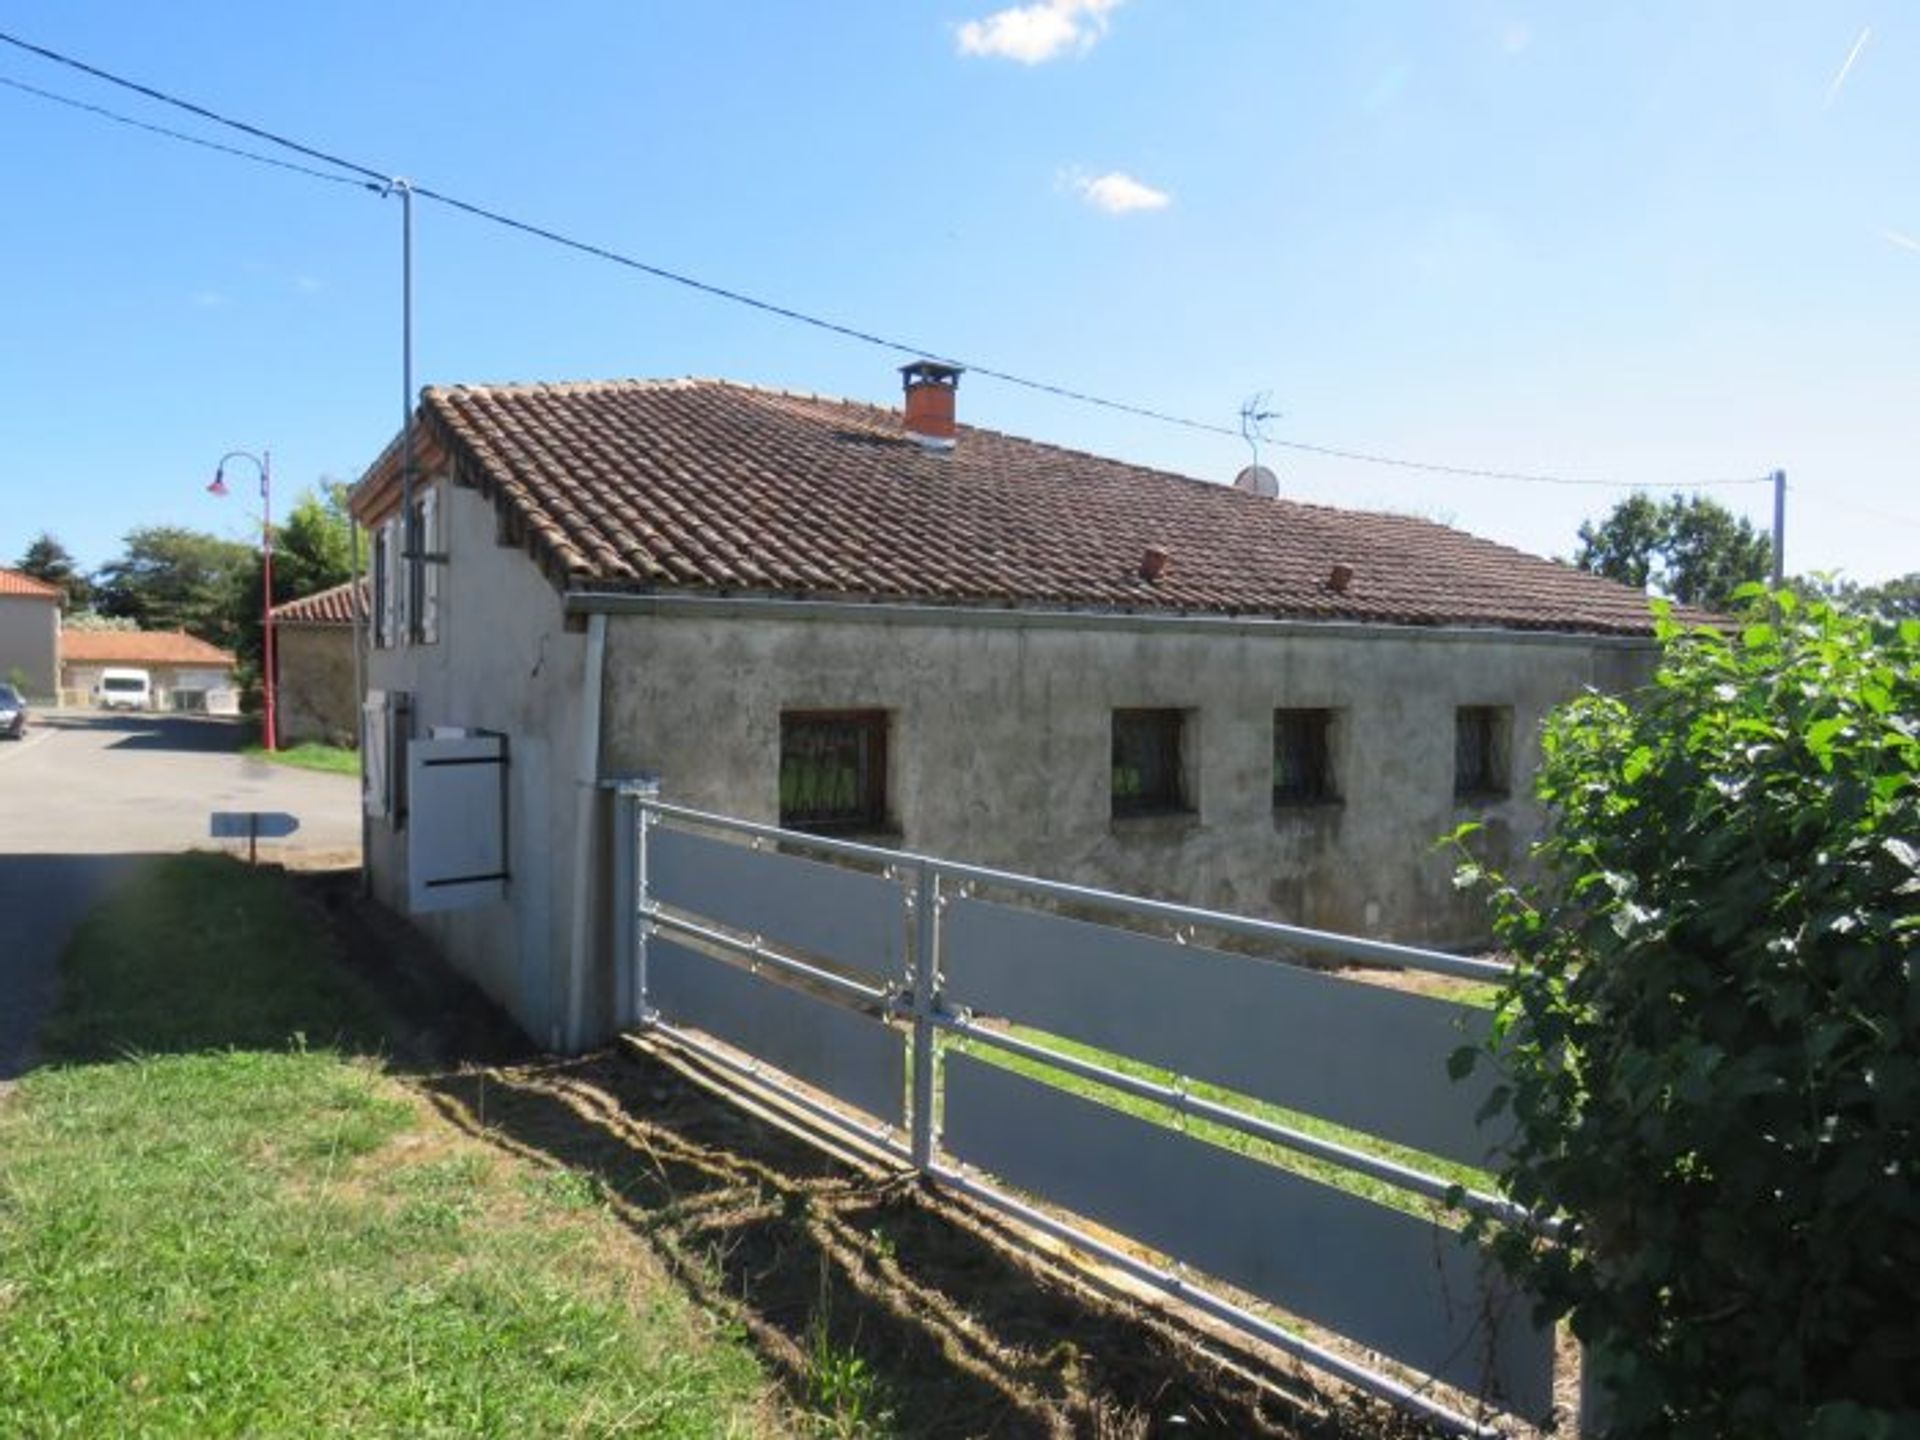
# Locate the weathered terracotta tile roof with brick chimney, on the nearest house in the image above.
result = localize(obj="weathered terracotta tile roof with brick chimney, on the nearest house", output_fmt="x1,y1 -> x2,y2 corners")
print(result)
366,380 -> 1689,634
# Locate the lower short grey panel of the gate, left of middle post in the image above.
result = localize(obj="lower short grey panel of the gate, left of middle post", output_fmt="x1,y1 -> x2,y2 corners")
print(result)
647,939 -> 906,1125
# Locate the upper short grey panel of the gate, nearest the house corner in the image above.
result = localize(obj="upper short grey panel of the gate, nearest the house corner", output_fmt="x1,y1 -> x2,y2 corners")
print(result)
647,826 -> 906,981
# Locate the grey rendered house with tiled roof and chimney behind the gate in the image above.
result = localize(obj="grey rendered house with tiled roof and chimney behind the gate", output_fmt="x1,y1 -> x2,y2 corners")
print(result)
353,365 -> 1689,1043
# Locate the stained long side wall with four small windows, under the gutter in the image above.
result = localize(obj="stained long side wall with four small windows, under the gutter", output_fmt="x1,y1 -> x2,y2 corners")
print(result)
603,616 -> 1651,947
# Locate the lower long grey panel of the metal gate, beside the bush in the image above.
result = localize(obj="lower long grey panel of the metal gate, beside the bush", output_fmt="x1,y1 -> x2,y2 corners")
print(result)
945,1054 -> 1553,1417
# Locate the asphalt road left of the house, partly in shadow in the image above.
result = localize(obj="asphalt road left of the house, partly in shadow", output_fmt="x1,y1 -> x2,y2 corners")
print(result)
0,710 -> 359,1083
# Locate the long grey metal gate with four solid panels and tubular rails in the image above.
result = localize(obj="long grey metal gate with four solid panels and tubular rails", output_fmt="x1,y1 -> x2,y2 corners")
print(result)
616,785 -> 1553,1434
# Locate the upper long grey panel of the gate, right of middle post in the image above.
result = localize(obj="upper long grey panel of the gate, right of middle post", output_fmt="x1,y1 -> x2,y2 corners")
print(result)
941,900 -> 1501,1164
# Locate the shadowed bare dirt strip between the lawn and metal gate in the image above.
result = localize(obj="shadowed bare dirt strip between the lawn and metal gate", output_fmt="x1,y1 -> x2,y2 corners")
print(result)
296,874 -> 1430,1440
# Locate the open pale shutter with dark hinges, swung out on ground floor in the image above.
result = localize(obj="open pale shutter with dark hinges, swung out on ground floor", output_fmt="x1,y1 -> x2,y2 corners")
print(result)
407,735 -> 507,914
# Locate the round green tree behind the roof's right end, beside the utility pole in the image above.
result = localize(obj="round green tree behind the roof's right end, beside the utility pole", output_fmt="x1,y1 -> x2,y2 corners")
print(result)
1572,492 -> 1772,611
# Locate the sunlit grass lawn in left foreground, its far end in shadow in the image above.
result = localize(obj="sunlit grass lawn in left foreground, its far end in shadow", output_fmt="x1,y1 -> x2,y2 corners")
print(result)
0,854 -> 789,1436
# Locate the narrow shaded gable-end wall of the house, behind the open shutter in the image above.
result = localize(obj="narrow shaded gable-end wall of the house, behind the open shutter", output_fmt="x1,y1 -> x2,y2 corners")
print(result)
367,482 -> 583,1044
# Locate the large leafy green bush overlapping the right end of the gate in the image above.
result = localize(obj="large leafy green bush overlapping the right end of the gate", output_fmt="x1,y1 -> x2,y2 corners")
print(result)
1455,591 -> 1920,1436
